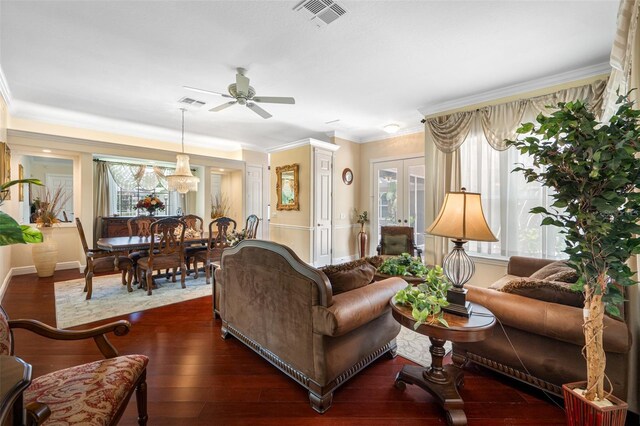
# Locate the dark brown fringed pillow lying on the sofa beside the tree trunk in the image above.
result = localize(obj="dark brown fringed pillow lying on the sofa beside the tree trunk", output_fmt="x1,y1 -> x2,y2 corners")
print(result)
498,277 -> 584,308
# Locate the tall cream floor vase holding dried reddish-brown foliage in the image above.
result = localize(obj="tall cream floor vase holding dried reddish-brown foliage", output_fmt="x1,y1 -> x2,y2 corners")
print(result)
31,187 -> 69,278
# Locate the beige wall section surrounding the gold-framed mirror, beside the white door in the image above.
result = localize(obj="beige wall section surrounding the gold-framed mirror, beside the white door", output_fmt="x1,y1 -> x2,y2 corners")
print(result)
269,145 -> 313,262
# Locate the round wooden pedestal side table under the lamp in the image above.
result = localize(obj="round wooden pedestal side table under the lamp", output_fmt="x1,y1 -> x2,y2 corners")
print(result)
390,299 -> 496,426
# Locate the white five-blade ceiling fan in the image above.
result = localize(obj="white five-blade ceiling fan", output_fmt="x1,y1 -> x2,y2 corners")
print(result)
182,68 -> 296,118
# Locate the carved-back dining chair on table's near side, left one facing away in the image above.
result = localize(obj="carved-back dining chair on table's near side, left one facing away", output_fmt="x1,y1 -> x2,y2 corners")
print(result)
137,217 -> 187,296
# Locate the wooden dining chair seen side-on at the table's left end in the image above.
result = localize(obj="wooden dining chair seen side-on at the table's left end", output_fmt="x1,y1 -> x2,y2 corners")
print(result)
76,218 -> 133,300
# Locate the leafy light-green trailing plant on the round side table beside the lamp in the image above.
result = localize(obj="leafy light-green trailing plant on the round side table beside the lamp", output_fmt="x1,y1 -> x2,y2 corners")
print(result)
394,266 -> 451,329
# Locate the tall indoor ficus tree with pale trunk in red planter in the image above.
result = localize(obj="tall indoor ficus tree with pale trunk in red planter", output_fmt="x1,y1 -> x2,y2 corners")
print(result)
508,96 -> 640,425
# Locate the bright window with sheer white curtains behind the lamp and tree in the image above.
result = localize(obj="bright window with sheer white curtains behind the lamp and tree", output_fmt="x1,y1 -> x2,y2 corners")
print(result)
460,119 -> 564,259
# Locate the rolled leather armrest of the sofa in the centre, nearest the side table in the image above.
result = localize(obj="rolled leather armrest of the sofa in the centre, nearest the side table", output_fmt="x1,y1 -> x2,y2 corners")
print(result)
313,277 -> 407,336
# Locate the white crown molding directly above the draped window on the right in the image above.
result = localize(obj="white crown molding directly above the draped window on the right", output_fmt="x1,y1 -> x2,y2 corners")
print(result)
418,62 -> 611,116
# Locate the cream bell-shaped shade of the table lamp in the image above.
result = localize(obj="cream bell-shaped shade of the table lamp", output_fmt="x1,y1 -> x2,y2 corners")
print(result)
427,190 -> 498,241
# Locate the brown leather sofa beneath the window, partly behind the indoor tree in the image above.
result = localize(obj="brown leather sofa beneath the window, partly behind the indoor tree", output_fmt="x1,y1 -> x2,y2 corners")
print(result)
453,256 -> 638,413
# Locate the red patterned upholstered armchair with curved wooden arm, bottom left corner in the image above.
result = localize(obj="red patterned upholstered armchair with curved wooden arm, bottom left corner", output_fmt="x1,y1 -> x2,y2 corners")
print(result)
0,306 -> 149,426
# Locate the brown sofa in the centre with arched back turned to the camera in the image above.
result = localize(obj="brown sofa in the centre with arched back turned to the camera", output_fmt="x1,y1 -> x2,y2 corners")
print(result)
215,240 -> 407,413
